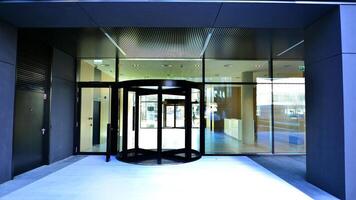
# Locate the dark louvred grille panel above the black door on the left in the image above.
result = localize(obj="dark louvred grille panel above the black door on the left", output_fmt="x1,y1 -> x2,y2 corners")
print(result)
16,37 -> 51,92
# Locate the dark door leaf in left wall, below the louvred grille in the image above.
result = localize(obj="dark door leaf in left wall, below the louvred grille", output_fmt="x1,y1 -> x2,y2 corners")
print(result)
13,90 -> 45,175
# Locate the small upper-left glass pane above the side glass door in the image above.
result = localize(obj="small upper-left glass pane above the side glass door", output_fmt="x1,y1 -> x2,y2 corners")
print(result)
78,58 -> 116,82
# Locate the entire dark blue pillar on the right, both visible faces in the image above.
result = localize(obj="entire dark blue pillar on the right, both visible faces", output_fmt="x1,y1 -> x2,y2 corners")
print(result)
305,6 -> 356,200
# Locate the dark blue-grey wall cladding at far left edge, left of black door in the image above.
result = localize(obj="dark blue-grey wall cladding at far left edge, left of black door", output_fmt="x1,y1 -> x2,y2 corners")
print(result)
0,22 -> 17,183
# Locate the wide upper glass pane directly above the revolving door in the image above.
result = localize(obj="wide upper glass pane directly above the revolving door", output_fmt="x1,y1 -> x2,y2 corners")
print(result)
119,58 -> 202,82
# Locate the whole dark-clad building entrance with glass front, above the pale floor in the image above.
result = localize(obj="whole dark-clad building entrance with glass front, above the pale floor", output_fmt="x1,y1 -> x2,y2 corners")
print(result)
0,1 -> 356,199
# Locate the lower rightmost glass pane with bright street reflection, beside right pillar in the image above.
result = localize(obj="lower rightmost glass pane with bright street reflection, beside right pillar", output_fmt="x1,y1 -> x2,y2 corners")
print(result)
273,78 -> 305,153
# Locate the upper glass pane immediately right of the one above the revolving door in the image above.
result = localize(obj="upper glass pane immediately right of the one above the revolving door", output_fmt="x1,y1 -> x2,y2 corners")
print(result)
205,59 -> 269,83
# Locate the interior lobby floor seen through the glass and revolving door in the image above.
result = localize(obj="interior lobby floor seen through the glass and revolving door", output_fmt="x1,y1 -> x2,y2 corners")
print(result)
84,128 -> 305,154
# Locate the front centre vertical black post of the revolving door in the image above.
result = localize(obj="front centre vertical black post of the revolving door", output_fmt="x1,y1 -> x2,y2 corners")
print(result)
157,86 -> 162,164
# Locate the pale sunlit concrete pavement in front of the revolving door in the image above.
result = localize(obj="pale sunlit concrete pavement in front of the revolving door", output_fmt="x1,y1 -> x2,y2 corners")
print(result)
0,156 -> 332,200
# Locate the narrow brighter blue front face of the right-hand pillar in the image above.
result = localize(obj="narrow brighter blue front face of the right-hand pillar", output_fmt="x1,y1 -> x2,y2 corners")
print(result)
340,5 -> 356,199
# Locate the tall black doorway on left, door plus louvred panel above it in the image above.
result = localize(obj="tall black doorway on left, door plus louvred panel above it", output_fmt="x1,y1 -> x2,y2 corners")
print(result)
12,29 -> 52,175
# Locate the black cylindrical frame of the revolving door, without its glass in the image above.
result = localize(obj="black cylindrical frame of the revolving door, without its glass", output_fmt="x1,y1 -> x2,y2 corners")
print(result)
117,80 -> 204,163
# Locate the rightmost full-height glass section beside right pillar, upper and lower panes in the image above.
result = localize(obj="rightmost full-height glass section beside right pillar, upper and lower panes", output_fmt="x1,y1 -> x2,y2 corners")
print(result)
273,60 -> 305,153
